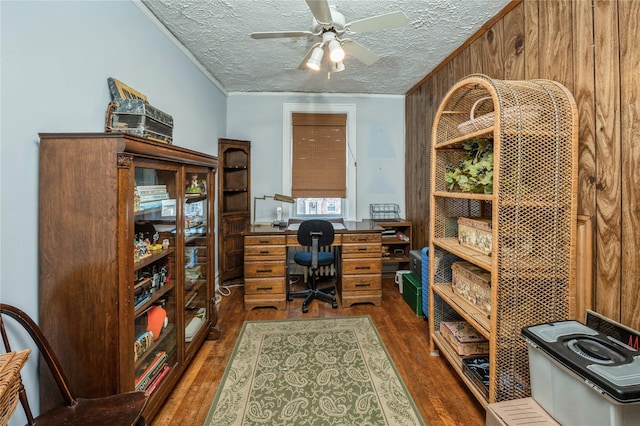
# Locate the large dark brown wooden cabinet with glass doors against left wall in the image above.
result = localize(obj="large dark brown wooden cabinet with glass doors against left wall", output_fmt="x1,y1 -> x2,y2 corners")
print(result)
39,133 -> 218,421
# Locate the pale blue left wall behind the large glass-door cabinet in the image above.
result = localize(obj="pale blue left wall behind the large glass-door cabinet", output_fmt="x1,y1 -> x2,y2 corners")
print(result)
0,0 -> 227,425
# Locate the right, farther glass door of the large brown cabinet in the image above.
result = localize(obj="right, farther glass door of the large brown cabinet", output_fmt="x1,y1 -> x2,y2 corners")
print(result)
184,168 -> 213,352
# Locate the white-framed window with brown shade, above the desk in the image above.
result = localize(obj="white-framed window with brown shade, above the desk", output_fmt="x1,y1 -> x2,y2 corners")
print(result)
283,104 -> 356,220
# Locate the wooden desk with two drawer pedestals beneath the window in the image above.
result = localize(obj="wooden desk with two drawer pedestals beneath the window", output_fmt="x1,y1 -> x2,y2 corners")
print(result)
244,219 -> 383,310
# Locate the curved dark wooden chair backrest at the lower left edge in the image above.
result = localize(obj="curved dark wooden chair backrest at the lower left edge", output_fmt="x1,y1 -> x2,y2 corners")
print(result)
0,303 -> 76,424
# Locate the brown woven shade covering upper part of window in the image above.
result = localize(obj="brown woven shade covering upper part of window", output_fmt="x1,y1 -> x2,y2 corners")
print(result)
291,113 -> 347,198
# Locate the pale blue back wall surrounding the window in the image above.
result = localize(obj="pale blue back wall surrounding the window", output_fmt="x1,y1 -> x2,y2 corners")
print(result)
227,93 -> 405,222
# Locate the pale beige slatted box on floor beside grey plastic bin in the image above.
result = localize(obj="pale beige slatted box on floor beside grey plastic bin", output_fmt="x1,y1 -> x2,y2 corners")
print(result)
486,398 -> 560,426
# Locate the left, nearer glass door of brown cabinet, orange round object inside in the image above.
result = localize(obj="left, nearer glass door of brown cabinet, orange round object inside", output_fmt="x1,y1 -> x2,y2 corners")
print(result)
132,162 -> 182,393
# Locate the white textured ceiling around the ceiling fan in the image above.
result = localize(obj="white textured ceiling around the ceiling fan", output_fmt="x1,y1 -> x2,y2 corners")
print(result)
143,0 -> 509,94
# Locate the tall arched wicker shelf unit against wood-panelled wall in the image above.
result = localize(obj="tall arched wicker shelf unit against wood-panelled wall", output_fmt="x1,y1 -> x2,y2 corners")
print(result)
429,75 -> 577,405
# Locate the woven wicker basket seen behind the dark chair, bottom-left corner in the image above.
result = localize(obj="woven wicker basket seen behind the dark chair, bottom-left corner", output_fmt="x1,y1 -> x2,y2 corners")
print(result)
0,349 -> 31,425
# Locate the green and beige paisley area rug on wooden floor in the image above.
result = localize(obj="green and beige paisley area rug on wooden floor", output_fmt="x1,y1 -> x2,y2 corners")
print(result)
204,316 -> 425,426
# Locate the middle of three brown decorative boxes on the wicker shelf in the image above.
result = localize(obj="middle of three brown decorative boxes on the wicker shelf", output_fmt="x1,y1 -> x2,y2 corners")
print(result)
451,261 -> 491,313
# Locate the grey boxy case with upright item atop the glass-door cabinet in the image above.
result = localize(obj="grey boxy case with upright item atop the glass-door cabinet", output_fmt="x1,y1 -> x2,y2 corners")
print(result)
104,77 -> 173,143
